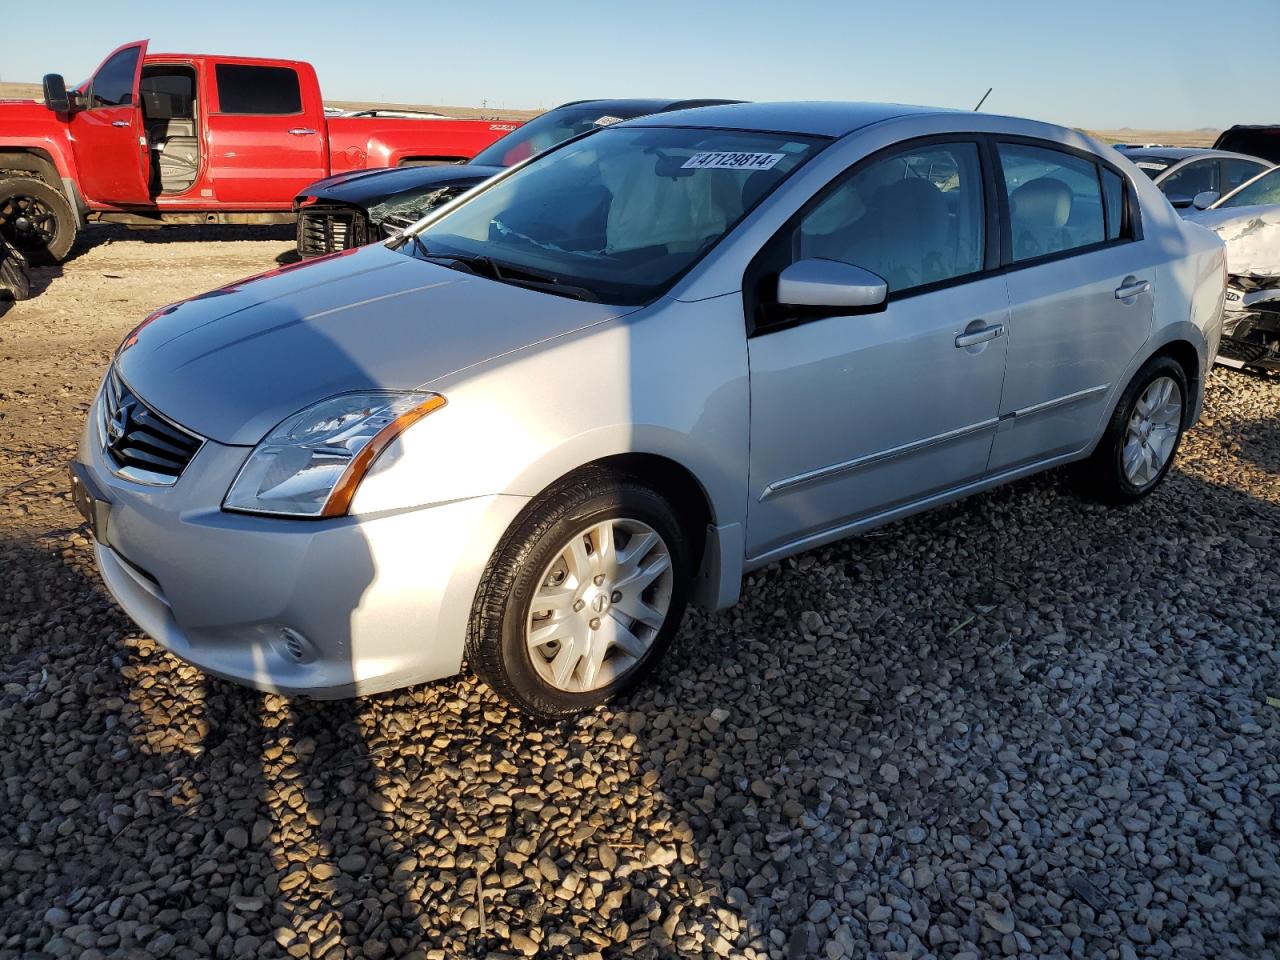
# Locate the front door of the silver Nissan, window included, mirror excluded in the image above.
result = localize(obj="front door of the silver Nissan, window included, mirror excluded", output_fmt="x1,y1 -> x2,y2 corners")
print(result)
746,140 -> 1009,559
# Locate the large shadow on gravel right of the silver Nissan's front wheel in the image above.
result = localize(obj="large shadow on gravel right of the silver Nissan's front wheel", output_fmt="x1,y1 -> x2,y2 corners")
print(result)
634,463 -> 1280,956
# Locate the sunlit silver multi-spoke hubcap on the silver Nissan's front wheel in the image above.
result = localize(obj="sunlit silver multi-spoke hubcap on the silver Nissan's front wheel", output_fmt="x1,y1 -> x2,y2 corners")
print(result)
525,520 -> 673,694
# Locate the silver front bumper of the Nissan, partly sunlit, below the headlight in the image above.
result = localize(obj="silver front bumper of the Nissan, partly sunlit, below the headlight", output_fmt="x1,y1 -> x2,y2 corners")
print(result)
78,399 -> 526,699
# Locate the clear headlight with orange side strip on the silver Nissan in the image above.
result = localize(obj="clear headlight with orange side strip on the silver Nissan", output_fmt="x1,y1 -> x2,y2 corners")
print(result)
223,390 -> 444,517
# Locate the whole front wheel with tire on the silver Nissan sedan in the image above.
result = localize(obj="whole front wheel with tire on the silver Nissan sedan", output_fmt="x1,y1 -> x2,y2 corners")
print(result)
467,471 -> 691,719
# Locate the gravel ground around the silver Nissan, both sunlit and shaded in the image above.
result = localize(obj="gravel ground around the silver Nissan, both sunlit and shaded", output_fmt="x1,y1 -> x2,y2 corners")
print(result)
0,232 -> 1280,960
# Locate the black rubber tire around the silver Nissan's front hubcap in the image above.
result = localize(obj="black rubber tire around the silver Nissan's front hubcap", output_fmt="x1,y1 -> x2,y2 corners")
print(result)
466,468 -> 692,721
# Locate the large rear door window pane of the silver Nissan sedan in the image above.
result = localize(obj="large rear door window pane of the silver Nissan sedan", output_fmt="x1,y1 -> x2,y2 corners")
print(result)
1000,143 -> 1107,262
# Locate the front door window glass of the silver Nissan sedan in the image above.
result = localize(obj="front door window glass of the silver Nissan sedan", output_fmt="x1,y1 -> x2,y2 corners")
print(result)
794,143 -> 986,292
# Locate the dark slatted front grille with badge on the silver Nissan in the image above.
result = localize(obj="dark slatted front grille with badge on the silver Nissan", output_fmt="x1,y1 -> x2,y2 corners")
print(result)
99,366 -> 204,485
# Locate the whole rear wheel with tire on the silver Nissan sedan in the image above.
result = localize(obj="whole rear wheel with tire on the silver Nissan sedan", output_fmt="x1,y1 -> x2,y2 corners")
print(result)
1075,357 -> 1187,504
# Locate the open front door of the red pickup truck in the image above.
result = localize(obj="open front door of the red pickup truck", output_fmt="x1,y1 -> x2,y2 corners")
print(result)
70,40 -> 151,205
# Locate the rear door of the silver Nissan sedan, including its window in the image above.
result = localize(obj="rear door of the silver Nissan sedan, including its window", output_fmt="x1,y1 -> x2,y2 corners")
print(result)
991,141 -> 1158,474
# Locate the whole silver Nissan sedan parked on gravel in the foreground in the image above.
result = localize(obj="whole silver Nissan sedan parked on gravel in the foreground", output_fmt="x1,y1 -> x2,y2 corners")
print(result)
73,104 -> 1224,717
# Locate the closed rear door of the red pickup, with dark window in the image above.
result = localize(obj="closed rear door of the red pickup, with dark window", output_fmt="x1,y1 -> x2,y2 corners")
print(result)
206,61 -> 328,209
